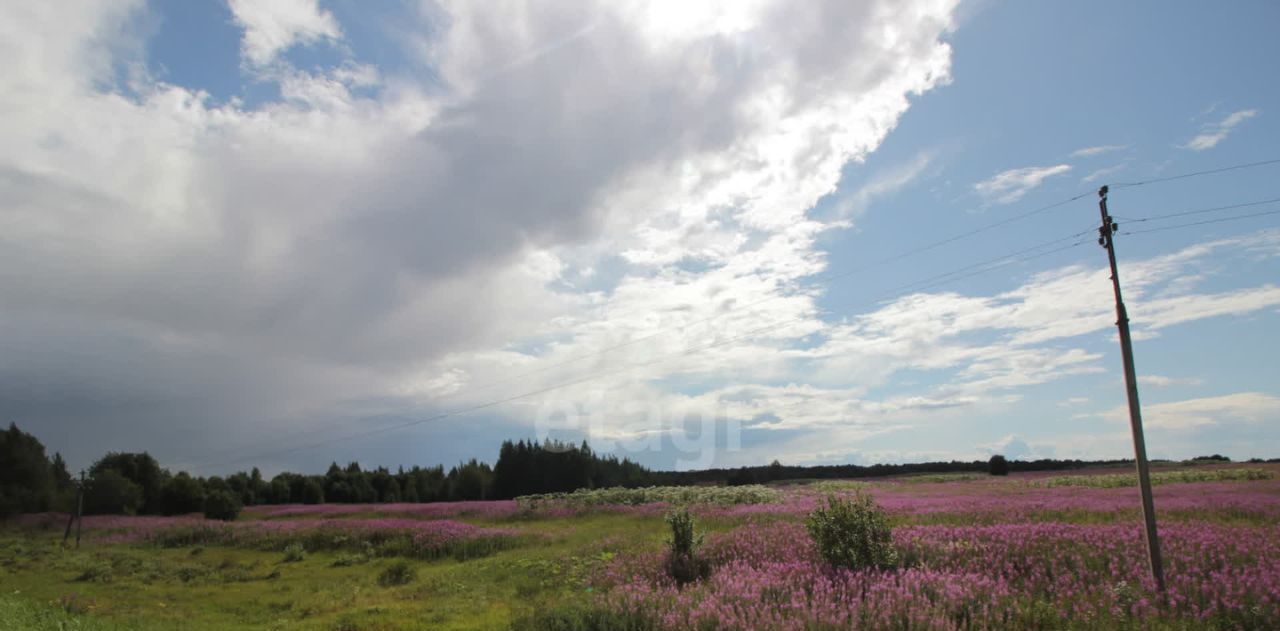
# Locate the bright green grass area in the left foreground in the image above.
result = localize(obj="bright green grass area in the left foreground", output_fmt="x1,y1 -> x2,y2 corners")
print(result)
0,513 -> 660,631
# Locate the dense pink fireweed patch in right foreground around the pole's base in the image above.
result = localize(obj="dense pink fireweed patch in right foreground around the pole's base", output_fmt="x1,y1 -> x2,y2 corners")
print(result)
595,522 -> 1280,630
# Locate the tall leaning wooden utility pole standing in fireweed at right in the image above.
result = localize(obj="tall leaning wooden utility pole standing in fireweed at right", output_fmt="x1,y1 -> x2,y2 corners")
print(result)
1098,187 -> 1165,593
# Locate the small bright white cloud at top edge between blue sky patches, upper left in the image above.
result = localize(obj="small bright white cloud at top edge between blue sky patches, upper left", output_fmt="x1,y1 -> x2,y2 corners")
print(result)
228,0 -> 342,67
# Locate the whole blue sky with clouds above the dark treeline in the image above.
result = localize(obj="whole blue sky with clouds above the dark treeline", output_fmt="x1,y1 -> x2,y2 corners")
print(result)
0,0 -> 1280,475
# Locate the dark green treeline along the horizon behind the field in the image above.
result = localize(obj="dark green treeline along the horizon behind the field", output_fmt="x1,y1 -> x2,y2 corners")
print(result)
0,425 -> 1274,520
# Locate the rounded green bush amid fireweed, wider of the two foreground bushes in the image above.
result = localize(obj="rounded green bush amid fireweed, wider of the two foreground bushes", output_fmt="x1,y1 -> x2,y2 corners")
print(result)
805,493 -> 899,570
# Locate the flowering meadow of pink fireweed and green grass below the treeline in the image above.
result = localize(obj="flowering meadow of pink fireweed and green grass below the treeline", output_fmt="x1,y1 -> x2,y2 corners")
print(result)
0,465 -> 1280,630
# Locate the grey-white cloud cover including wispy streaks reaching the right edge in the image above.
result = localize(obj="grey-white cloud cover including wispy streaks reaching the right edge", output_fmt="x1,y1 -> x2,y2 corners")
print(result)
0,0 -> 1280,466
